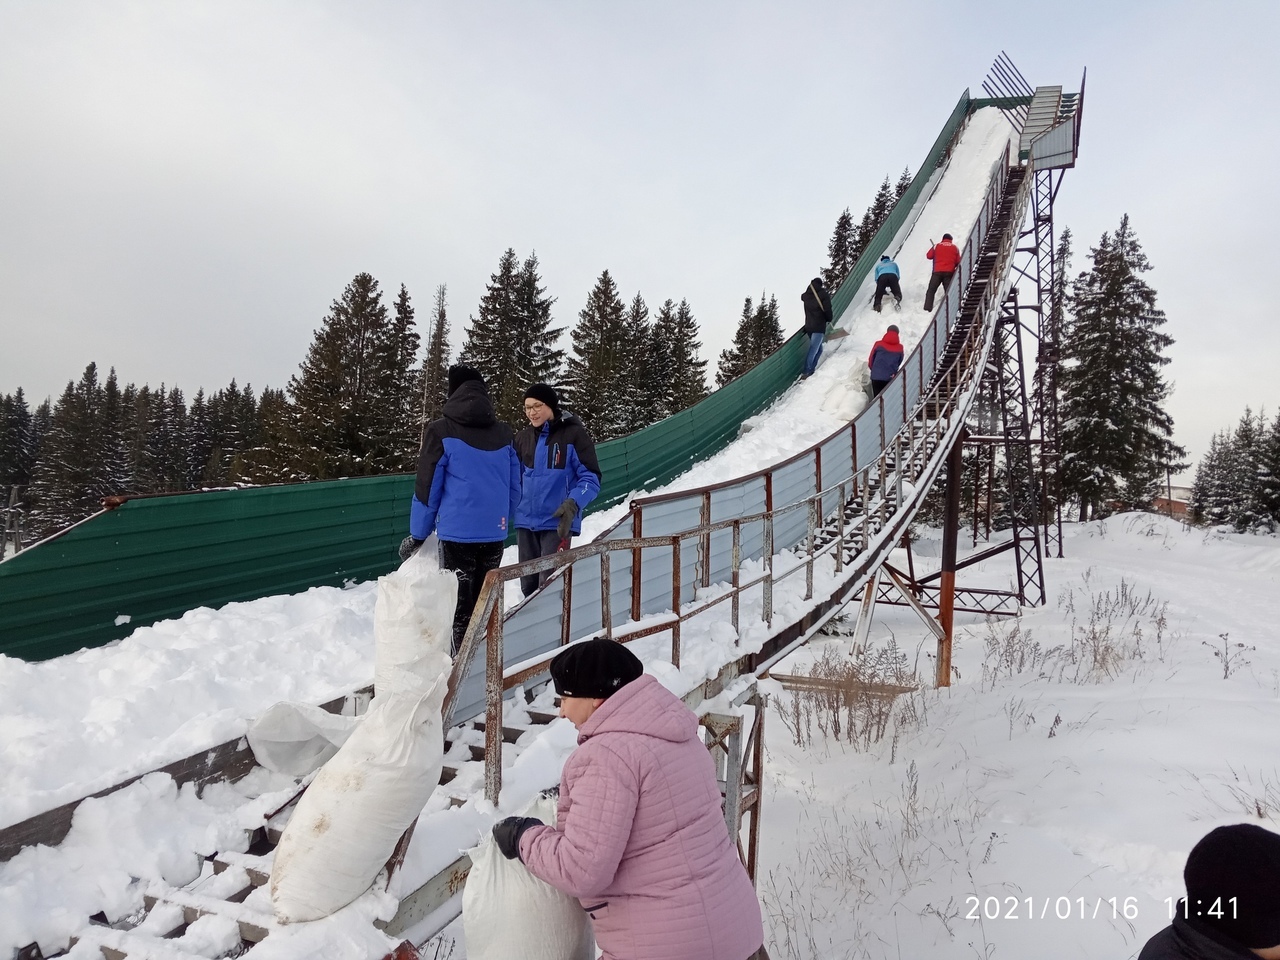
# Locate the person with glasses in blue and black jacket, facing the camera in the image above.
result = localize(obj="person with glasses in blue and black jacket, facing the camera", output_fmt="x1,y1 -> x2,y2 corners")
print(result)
516,383 -> 600,596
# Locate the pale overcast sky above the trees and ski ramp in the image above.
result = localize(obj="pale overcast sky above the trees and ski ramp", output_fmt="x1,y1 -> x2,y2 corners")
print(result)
0,0 -> 1280,481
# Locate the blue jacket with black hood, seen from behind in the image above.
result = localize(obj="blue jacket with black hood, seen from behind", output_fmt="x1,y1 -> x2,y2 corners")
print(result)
408,380 -> 520,543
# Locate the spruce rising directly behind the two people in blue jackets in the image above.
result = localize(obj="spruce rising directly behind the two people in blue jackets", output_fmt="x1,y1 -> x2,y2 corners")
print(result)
458,248 -> 564,428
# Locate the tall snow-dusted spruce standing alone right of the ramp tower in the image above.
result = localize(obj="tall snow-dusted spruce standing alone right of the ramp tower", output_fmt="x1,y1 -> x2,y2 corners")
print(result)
1060,214 -> 1184,520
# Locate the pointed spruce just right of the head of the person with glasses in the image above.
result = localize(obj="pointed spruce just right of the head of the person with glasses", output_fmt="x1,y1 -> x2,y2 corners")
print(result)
564,270 -> 631,442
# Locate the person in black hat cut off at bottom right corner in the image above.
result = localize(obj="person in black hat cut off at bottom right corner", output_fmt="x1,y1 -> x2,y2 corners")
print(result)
1138,823 -> 1280,960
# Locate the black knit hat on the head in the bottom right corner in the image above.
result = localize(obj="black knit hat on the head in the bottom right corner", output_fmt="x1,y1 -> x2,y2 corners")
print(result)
1183,823 -> 1280,950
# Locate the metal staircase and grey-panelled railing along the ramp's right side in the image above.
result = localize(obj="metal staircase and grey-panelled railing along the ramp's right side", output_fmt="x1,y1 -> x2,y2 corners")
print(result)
444,136 -> 1032,800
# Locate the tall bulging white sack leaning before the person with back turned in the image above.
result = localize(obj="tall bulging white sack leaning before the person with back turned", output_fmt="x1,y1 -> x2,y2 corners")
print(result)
270,550 -> 458,923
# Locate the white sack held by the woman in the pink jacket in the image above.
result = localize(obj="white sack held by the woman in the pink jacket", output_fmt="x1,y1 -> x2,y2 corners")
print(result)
462,797 -> 595,960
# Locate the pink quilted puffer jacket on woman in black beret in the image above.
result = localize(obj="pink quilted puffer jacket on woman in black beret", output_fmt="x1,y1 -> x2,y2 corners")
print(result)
520,675 -> 764,960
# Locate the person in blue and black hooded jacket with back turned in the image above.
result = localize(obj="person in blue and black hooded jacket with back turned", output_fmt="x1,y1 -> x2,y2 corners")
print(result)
399,365 -> 520,657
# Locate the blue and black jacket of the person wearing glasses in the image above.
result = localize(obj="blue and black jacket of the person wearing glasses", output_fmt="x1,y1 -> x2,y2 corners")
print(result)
516,413 -> 600,536
